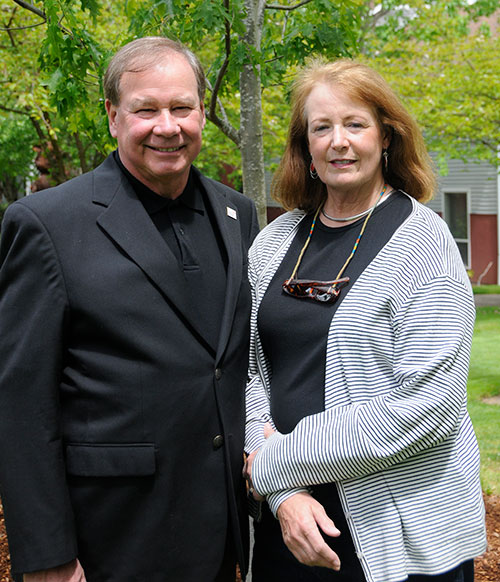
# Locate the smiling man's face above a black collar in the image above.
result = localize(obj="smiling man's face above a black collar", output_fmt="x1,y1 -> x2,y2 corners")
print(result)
106,53 -> 205,198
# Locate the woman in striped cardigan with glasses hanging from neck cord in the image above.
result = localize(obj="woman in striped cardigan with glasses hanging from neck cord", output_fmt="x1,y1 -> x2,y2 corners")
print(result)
246,60 -> 486,582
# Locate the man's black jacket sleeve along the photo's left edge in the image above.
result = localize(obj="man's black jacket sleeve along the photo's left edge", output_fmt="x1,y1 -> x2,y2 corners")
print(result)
0,203 -> 77,572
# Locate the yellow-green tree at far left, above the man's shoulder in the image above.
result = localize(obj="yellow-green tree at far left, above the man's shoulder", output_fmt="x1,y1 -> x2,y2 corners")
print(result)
0,1 -> 112,189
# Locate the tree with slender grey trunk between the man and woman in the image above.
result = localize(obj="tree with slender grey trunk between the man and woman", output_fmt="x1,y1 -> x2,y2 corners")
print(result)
0,0 -> 358,223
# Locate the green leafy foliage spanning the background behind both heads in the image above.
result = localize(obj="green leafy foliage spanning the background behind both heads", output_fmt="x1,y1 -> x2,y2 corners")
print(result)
0,0 -> 500,201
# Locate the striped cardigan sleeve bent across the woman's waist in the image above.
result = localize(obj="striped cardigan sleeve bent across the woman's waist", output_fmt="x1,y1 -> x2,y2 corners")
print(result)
253,274 -> 475,495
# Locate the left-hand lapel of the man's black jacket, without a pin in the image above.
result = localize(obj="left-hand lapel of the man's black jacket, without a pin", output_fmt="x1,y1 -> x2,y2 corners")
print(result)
94,156 -> 214,351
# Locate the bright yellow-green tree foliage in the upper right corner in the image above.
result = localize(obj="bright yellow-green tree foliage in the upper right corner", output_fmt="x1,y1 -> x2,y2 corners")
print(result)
359,0 -> 500,171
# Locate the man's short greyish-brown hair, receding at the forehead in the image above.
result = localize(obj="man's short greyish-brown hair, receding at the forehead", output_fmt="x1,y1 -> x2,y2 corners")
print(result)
103,36 -> 206,105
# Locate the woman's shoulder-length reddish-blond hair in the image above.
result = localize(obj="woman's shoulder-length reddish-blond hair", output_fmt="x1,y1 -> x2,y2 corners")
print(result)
271,59 -> 436,212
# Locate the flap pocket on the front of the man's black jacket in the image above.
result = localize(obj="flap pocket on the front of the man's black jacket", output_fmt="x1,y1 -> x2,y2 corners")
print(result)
66,443 -> 156,477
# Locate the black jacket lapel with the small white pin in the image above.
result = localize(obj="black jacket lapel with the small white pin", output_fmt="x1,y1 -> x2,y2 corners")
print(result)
198,174 -> 243,360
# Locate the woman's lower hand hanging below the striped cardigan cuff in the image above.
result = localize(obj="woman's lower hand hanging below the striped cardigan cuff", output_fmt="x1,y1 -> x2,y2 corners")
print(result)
277,492 -> 340,570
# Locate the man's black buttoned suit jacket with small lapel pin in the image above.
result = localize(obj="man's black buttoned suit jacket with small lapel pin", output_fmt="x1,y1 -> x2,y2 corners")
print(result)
0,157 -> 257,582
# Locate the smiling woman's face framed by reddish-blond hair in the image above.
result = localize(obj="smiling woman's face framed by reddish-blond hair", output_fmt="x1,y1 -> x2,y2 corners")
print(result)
305,83 -> 389,194
